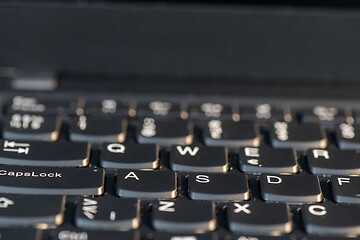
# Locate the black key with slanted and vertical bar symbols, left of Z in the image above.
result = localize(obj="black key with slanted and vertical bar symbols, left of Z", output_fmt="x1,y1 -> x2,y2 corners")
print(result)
75,197 -> 140,231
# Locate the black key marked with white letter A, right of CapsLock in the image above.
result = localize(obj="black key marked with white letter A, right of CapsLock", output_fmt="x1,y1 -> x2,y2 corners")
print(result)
116,169 -> 177,199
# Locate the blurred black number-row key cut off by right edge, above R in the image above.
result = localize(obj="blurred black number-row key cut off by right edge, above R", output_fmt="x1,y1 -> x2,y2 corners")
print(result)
336,123 -> 360,150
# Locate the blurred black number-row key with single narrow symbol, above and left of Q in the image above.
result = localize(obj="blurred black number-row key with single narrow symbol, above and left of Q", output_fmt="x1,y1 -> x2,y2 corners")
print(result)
70,115 -> 127,143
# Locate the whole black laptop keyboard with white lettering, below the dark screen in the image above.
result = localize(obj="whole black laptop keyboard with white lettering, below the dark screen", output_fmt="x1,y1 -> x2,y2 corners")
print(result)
0,96 -> 360,240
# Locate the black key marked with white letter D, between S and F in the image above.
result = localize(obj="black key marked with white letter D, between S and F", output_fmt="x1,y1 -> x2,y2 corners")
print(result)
260,174 -> 323,203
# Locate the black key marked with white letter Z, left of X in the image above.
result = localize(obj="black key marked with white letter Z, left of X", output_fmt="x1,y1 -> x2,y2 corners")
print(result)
152,200 -> 217,233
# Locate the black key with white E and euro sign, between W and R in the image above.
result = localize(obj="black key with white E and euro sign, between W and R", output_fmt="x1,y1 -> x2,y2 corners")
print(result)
239,146 -> 299,174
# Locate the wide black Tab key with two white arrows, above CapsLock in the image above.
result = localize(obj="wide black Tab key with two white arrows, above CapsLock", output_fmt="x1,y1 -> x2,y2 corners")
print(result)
0,140 -> 90,167
